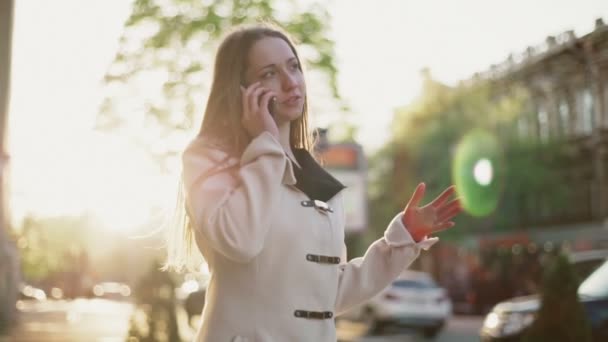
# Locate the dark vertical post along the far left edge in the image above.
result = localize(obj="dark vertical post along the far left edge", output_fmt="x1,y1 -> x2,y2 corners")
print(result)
0,0 -> 19,333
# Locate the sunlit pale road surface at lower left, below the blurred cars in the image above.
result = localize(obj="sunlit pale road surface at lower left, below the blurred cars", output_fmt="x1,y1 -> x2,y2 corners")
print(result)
9,299 -> 133,342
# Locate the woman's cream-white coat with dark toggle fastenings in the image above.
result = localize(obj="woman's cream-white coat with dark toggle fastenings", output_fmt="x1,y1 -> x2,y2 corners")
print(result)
183,132 -> 437,342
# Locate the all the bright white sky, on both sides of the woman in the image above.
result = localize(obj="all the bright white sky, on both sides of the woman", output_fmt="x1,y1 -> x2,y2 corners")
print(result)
8,0 -> 608,229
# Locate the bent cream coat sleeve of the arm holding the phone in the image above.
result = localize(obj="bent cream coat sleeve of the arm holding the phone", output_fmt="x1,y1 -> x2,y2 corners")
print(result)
183,132 -> 288,263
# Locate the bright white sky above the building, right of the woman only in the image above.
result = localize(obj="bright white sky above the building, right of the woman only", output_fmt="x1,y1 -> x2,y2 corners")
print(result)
330,0 -> 608,150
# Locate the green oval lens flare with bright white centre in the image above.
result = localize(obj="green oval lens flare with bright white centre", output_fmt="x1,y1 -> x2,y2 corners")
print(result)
452,129 -> 502,217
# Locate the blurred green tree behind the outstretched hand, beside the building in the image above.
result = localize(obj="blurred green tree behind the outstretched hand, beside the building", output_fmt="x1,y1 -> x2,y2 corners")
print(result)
370,70 -> 567,243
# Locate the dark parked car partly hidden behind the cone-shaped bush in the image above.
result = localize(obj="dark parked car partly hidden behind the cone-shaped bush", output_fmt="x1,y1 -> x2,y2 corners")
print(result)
480,260 -> 608,342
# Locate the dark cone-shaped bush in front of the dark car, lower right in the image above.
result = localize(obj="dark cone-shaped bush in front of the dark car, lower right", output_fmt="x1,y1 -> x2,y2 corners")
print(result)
524,255 -> 591,342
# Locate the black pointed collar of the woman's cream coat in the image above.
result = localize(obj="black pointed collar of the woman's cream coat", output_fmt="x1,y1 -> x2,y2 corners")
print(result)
284,149 -> 346,202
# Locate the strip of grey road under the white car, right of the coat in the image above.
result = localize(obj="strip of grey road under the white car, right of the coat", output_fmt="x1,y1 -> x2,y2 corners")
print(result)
338,316 -> 483,342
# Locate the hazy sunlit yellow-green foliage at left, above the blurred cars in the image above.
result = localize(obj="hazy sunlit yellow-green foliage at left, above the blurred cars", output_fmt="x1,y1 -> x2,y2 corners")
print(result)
13,214 -> 164,295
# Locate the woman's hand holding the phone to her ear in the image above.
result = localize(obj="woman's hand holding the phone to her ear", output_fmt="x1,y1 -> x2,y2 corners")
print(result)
241,82 -> 279,139
